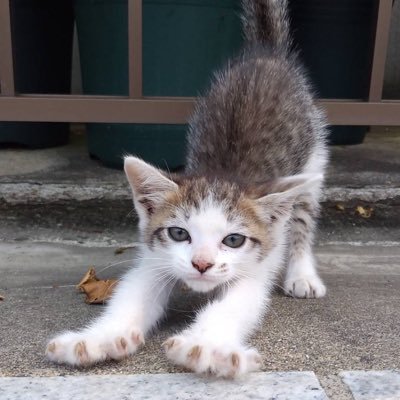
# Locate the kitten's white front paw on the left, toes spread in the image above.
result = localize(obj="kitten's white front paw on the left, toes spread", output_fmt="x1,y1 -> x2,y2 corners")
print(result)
46,329 -> 144,366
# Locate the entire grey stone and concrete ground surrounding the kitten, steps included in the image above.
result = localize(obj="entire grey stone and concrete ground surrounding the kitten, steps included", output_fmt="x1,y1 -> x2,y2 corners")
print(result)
0,130 -> 400,400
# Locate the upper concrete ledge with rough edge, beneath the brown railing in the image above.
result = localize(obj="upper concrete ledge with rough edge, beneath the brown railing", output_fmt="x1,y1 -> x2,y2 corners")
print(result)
0,128 -> 400,205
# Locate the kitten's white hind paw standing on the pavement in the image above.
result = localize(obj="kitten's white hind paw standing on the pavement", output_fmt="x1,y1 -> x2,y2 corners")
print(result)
284,275 -> 326,299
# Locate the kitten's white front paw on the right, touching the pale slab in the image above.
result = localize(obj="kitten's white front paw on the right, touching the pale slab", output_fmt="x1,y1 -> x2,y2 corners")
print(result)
163,335 -> 262,378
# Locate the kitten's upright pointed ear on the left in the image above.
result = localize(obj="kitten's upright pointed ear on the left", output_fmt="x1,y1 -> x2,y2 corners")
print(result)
124,156 -> 178,223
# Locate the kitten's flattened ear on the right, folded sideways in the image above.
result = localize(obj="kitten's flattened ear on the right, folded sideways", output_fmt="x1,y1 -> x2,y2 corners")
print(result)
256,174 -> 323,222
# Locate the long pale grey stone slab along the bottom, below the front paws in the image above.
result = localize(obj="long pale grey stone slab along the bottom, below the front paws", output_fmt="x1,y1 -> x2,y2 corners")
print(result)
0,372 -> 328,400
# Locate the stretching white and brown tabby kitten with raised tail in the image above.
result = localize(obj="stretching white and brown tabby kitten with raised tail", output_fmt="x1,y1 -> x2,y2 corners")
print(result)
46,0 -> 327,377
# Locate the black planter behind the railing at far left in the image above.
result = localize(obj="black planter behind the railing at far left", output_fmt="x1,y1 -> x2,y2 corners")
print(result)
0,0 -> 73,148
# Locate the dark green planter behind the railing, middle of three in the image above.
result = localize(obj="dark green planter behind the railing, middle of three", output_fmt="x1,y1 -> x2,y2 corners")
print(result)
74,0 -> 242,169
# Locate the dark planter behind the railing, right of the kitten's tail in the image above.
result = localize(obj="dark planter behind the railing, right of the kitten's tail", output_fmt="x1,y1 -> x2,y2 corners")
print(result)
290,0 -> 377,144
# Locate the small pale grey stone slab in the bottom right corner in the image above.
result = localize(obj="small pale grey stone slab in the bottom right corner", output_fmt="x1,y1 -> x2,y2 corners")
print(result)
340,371 -> 400,400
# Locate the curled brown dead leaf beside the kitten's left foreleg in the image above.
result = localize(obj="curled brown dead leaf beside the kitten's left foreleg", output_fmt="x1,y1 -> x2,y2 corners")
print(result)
76,267 -> 118,304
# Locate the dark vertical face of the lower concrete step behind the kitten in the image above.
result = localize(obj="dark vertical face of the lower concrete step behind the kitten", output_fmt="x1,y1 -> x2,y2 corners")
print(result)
0,200 -> 400,247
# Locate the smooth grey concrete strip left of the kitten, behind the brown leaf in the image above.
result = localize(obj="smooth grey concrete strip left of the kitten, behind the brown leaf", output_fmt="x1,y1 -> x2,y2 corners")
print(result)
0,242 -> 137,290
